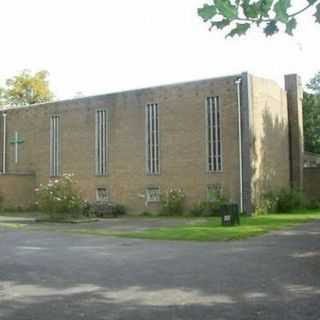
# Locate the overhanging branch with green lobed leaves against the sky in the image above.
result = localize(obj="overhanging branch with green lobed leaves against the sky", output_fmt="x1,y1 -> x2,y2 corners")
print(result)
198,0 -> 320,37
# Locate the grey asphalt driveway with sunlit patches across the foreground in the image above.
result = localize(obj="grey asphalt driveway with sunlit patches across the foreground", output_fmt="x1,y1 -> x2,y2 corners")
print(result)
0,222 -> 320,320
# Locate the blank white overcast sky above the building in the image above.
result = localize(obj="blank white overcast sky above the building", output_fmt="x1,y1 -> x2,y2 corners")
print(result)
0,0 -> 320,99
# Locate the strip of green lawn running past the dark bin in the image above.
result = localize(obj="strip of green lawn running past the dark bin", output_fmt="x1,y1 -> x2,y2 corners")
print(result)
78,210 -> 320,241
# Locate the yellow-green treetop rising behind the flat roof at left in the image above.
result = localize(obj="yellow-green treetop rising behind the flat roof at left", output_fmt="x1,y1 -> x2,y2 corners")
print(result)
0,70 -> 53,106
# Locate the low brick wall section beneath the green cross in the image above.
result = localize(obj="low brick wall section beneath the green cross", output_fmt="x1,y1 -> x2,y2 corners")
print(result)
0,174 -> 35,207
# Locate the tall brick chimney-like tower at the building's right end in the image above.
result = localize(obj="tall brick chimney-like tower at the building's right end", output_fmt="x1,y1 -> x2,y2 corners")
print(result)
285,74 -> 304,190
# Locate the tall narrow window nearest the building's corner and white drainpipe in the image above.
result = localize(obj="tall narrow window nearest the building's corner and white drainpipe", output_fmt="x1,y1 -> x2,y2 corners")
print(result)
206,97 -> 223,172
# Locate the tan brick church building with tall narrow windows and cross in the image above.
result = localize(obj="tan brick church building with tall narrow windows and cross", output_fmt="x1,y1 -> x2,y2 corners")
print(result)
0,73 -> 303,212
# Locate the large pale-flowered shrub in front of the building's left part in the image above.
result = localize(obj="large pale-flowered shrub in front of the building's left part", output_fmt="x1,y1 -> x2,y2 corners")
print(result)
35,174 -> 85,219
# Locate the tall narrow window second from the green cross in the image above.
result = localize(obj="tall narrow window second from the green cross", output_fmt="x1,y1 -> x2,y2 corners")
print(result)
96,110 -> 108,176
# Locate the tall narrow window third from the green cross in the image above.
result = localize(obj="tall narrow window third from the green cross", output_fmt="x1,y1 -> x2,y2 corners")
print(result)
145,103 -> 160,175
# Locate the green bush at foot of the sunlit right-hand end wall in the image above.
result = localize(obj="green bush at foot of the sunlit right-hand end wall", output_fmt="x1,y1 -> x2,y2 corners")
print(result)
256,189 -> 307,213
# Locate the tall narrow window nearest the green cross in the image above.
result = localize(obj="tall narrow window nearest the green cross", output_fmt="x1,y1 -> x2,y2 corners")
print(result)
50,115 -> 61,177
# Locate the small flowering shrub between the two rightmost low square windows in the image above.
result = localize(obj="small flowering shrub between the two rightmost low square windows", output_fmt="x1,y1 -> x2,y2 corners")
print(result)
160,189 -> 185,215
